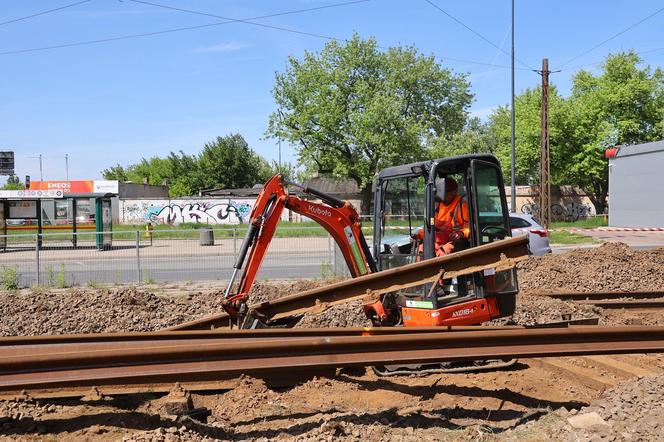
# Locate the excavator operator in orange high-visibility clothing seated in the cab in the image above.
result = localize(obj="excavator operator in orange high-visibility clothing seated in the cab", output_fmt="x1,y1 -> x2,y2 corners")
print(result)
414,178 -> 470,256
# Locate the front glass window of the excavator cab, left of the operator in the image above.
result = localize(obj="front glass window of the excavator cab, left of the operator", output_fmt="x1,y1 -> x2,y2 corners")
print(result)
378,176 -> 425,270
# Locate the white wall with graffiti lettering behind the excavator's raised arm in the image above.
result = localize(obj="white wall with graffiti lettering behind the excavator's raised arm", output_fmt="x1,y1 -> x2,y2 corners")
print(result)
118,198 -> 280,225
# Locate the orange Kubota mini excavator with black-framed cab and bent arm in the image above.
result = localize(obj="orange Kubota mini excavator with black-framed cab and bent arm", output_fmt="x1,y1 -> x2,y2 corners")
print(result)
223,154 -> 518,334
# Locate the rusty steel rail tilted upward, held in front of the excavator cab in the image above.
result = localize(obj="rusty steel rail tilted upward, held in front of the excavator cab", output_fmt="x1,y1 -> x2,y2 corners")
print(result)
166,236 -> 528,330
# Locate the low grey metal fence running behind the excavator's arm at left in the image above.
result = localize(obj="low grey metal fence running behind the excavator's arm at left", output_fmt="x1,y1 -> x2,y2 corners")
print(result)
0,227 -> 343,287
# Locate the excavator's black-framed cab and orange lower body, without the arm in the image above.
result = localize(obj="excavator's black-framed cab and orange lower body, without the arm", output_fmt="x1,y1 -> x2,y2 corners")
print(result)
364,154 -> 518,326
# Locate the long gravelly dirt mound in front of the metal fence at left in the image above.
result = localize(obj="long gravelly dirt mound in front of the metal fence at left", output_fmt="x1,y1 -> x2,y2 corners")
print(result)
0,281 -> 327,336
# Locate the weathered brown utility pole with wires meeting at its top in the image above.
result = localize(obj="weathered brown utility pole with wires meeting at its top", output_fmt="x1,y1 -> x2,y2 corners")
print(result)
539,58 -> 551,229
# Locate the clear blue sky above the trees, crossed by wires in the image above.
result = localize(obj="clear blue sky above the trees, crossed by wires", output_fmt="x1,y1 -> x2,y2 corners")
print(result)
0,0 -> 664,181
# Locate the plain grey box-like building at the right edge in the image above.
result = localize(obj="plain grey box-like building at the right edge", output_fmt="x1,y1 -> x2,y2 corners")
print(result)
605,141 -> 664,227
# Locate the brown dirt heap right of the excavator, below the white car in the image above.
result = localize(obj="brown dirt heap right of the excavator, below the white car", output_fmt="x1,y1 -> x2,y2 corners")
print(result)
519,242 -> 664,292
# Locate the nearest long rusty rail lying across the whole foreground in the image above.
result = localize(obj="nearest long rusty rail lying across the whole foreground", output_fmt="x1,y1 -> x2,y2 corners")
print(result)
0,326 -> 664,390
